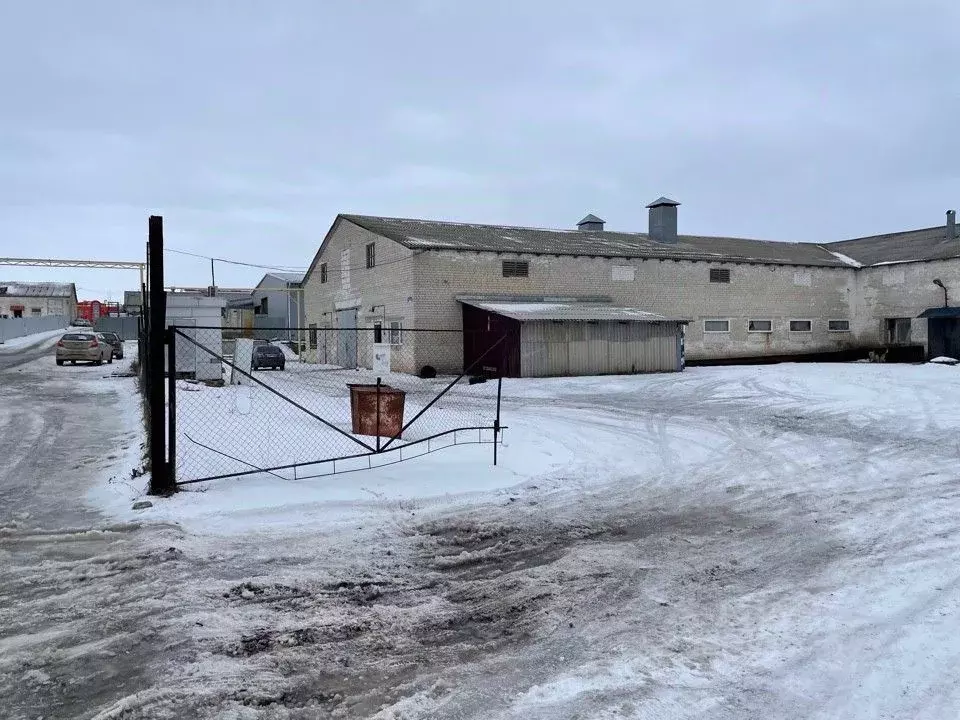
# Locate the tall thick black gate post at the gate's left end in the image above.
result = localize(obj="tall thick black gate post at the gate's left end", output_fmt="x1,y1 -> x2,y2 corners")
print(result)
147,215 -> 174,495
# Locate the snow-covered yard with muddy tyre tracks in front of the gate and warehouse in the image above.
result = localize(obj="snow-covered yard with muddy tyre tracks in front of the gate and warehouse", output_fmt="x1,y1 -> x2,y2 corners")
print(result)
0,356 -> 960,720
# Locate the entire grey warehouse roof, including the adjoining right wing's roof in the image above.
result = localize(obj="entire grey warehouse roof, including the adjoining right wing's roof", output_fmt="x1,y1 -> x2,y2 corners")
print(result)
340,217 -> 960,268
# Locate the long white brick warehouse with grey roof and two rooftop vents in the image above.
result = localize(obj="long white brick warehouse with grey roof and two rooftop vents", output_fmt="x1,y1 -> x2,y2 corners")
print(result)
304,198 -> 960,370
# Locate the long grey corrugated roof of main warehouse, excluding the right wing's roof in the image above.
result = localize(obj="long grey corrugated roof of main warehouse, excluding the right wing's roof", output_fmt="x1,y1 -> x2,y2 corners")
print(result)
341,215 -> 849,267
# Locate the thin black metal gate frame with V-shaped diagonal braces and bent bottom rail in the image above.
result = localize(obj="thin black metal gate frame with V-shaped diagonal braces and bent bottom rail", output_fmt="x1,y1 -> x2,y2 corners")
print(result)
165,325 -> 508,486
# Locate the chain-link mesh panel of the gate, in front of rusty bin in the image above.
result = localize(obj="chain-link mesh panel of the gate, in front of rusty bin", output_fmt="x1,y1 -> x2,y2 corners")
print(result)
168,327 -> 510,484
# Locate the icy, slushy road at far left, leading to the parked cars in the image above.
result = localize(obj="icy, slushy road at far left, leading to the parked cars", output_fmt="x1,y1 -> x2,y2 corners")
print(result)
0,341 -> 172,720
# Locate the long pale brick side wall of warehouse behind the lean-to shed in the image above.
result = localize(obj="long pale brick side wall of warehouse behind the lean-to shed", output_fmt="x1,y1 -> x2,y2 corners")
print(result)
415,251 -> 860,360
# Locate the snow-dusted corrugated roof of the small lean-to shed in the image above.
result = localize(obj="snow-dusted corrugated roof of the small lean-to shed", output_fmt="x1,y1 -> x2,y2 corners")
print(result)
457,295 -> 686,322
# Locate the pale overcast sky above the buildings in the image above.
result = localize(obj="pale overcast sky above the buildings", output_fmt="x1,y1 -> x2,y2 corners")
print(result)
0,0 -> 960,299
